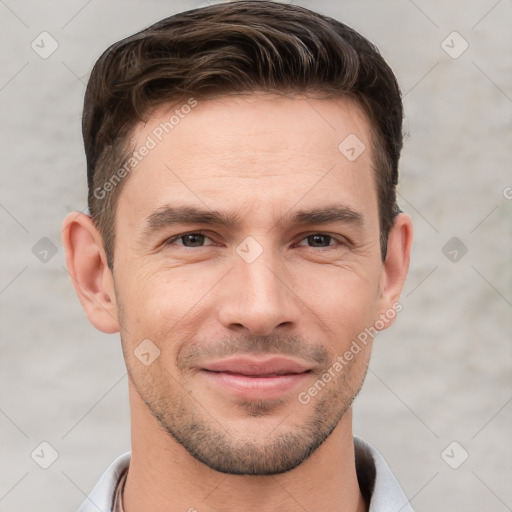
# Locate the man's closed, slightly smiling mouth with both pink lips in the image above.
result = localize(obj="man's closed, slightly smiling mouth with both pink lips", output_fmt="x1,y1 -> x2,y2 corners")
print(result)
201,357 -> 312,400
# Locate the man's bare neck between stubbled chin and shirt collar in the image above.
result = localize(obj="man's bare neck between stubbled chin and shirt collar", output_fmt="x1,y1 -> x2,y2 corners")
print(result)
123,387 -> 368,512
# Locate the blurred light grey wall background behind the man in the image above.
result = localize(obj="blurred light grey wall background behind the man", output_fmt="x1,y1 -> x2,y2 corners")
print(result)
0,0 -> 512,512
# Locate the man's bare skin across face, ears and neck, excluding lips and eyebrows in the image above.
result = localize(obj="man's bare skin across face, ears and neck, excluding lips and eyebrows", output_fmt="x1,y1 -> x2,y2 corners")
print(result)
63,94 -> 412,512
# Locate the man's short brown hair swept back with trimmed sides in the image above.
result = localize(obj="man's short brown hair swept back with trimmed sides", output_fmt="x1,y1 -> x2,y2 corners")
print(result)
82,0 -> 403,268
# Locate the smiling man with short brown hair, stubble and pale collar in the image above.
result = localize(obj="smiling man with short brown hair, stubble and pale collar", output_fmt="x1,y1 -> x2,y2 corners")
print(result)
63,1 -> 412,512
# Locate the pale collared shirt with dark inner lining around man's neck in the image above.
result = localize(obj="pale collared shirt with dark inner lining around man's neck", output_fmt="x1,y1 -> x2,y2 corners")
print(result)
78,436 -> 413,512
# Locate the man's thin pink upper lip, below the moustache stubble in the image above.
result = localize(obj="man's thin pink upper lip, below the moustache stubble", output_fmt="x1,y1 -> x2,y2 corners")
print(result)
203,357 -> 311,376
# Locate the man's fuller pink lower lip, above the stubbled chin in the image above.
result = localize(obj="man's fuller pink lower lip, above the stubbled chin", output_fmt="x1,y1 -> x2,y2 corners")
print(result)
201,370 -> 310,400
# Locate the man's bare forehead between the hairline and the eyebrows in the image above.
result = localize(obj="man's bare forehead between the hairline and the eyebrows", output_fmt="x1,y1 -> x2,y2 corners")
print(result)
118,94 -> 376,227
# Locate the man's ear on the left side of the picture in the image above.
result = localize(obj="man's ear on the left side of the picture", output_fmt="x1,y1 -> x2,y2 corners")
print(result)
62,212 -> 119,334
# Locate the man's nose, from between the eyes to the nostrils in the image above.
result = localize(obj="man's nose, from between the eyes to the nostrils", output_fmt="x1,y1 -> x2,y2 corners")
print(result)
218,247 -> 300,336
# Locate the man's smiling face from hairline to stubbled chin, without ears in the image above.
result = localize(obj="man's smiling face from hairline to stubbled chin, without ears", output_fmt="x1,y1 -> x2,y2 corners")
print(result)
114,95 -> 389,475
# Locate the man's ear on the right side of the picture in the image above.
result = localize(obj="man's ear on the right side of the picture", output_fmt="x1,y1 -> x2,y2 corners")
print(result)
380,213 -> 413,328
